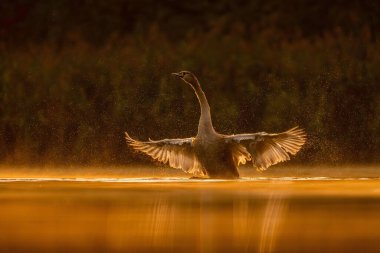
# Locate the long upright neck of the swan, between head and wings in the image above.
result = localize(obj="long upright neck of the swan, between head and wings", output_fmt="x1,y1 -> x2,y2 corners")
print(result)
192,80 -> 216,136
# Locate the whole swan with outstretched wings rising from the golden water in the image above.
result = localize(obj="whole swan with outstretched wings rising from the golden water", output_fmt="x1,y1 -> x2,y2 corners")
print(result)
125,71 -> 306,178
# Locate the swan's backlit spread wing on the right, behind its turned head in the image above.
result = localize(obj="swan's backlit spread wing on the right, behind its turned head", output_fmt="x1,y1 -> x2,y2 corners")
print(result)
225,127 -> 306,171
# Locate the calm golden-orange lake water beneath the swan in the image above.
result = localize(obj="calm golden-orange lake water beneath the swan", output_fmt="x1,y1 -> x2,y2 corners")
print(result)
0,167 -> 380,252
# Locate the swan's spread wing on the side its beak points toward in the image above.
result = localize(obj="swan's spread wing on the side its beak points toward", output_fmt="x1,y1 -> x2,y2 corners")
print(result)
125,132 -> 206,176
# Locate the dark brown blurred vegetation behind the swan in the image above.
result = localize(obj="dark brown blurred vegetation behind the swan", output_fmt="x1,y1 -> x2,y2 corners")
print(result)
0,0 -> 380,164
